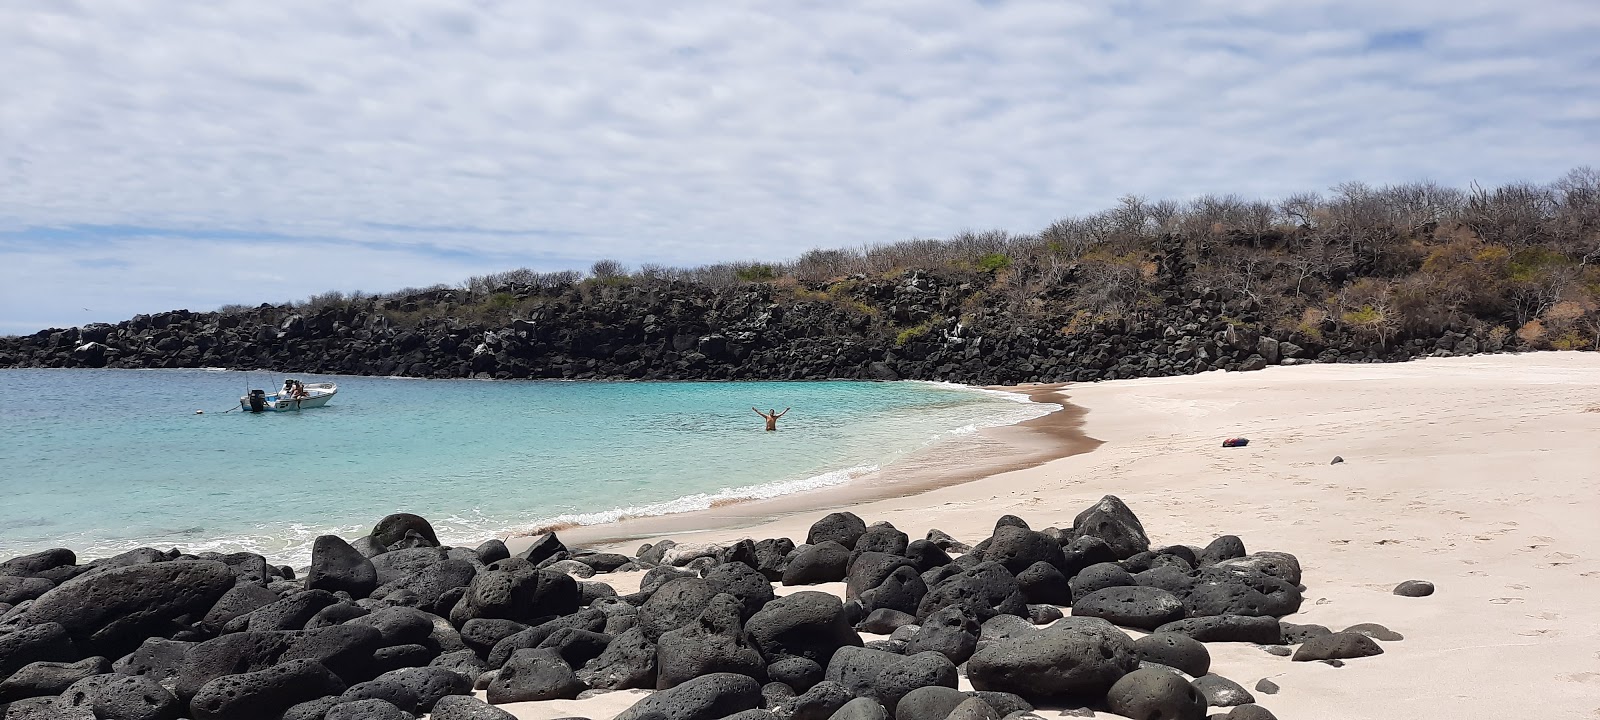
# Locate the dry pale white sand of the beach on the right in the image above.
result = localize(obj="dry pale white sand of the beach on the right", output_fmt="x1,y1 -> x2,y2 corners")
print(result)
480,354 -> 1600,720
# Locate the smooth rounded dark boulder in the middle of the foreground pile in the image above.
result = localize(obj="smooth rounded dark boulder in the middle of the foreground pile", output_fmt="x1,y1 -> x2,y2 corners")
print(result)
744,590 -> 861,667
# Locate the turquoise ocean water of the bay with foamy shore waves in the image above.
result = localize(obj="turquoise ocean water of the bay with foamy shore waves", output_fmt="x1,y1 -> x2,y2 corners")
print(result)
0,370 -> 1053,565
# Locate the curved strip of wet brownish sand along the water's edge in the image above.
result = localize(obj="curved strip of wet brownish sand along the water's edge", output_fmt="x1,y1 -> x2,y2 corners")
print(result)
518,382 -> 1102,552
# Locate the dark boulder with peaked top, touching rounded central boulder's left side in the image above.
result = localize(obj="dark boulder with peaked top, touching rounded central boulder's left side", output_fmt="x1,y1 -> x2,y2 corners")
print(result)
656,592 -> 766,690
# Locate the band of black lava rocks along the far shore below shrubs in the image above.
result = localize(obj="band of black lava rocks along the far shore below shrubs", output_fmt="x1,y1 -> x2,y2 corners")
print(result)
0,270 -> 1515,384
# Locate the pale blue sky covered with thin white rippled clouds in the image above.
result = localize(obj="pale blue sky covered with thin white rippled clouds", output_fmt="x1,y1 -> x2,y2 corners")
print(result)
0,0 -> 1600,334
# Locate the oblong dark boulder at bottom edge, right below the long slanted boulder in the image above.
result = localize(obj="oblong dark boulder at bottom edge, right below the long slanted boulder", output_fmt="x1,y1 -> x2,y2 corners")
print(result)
189,659 -> 346,720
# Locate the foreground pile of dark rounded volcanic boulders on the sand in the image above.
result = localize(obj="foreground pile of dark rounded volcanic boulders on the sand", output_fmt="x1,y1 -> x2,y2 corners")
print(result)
0,496 -> 1398,720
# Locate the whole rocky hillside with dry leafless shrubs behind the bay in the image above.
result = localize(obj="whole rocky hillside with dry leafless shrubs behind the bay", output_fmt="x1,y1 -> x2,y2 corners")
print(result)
0,168 -> 1600,384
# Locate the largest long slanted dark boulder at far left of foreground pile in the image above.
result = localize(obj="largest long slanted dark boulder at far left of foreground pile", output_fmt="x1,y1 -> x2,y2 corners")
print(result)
21,560 -> 234,664
